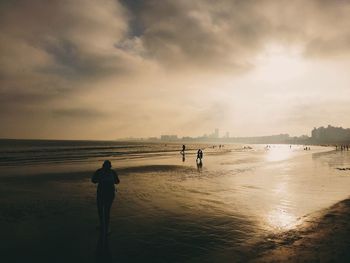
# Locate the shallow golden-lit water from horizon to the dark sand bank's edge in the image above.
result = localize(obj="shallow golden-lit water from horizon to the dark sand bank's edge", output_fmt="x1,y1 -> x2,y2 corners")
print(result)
0,141 -> 350,262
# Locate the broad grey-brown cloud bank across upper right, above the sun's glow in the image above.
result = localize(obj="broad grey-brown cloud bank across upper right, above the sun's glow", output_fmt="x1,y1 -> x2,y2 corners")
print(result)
122,0 -> 350,70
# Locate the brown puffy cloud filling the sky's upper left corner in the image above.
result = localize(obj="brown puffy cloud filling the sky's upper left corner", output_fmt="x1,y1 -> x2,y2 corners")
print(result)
0,0 -> 132,117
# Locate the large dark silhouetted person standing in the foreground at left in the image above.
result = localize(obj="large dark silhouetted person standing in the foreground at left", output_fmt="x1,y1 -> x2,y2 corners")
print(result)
91,160 -> 120,234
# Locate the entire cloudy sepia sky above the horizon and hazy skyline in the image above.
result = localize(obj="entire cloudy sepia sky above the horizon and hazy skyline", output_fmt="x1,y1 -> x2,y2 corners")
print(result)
0,0 -> 350,140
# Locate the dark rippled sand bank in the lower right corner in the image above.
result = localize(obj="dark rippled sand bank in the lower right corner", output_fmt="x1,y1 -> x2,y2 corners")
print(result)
251,198 -> 350,262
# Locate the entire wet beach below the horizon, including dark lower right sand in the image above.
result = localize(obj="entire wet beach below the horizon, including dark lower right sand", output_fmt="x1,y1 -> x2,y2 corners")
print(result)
0,144 -> 350,262
